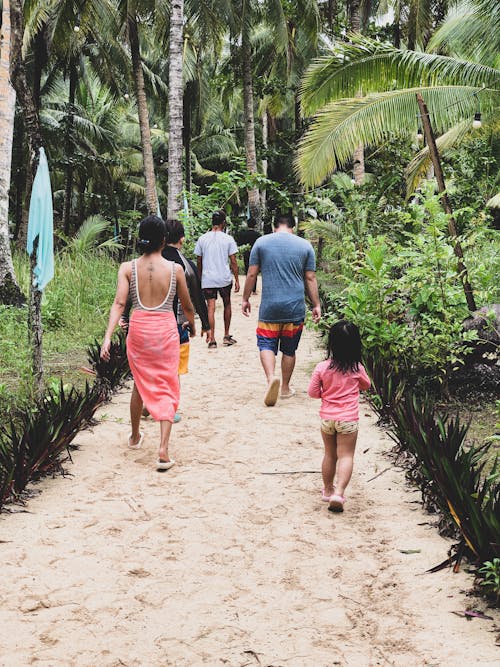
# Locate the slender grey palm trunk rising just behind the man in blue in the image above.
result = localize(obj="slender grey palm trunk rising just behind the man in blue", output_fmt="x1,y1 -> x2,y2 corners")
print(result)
241,28 -> 262,229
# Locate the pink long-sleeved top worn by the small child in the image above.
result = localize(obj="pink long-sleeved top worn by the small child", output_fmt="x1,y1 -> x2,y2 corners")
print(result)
308,359 -> 370,421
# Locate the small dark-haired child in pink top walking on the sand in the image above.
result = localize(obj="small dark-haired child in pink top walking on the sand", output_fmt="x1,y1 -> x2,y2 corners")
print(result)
308,320 -> 370,512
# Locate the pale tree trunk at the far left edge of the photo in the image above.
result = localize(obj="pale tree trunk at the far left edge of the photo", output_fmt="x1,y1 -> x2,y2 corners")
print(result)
0,0 -> 25,306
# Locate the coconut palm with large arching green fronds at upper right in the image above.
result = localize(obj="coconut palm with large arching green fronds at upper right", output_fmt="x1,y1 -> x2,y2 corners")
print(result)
297,0 -> 500,186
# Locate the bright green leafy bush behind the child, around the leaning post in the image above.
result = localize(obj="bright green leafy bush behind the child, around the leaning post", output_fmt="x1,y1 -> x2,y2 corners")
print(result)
312,187 -> 496,386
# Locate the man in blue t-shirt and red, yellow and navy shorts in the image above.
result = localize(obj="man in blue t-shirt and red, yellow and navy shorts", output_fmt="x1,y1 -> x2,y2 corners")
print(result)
242,215 -> 321,406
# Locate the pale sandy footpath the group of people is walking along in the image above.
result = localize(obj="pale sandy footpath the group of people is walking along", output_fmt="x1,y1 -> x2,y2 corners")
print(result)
0,288 -> 500,667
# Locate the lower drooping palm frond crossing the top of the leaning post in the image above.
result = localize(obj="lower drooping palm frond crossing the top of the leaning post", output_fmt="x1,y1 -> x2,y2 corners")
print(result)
296,86 -> 498,186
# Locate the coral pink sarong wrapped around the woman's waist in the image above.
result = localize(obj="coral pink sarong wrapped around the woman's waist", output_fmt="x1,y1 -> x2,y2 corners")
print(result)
127,310 -> 180,422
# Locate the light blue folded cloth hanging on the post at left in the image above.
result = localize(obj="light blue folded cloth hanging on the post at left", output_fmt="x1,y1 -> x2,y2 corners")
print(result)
26,148 -> 54,292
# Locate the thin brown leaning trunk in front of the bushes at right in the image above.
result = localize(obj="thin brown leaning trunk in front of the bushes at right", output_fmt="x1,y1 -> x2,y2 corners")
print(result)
417,93 -> 477,312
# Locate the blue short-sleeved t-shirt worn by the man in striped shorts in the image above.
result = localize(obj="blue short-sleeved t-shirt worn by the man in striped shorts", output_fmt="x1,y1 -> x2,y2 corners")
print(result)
249,232 -> 316,322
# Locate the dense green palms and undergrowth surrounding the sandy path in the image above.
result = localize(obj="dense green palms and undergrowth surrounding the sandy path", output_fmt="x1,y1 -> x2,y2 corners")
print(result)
0,0 -> 500,596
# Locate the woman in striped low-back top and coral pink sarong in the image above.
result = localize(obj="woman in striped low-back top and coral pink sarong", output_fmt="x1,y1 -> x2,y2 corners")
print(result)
101,215 -> 195,470
